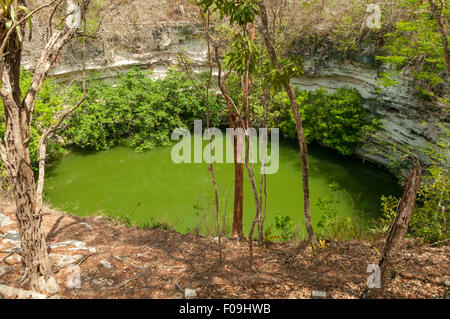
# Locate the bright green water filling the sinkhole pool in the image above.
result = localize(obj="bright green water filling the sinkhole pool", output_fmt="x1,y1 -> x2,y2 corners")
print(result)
45,137 -> 399,232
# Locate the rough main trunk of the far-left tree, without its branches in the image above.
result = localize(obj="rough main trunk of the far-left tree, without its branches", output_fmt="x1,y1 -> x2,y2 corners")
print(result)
2,47 -> 51,288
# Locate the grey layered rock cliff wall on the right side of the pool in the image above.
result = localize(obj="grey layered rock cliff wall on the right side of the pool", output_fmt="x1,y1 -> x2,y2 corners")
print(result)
293,58 -> 450,165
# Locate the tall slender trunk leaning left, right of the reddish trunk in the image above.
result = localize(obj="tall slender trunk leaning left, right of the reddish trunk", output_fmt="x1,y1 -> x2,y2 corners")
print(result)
258,1 -> 319,251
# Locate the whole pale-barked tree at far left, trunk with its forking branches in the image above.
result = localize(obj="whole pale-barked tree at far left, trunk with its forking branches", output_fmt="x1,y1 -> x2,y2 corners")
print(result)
0,1 -> 88,289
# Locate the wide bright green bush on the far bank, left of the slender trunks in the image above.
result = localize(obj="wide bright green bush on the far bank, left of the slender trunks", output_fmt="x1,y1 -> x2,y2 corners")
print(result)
65,69 -> 221,151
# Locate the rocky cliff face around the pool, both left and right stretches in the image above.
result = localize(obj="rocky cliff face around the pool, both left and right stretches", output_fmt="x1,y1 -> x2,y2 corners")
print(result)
24,22 -> 450,170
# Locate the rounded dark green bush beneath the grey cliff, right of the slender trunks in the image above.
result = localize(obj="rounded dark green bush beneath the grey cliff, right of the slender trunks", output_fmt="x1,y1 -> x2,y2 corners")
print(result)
271,88 -> 379,155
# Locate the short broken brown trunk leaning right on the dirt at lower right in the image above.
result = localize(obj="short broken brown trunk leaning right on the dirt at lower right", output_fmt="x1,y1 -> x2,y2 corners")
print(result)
361,164 -> 422,299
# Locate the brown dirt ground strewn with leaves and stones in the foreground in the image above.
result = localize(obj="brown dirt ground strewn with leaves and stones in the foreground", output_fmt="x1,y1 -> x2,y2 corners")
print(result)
0,200 -> 450,299
